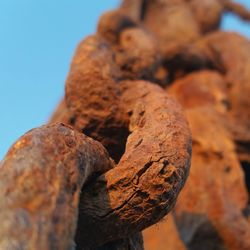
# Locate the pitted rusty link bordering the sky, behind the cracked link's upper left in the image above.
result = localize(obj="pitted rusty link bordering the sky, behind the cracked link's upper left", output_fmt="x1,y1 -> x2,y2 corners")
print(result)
64,35 -> 128,161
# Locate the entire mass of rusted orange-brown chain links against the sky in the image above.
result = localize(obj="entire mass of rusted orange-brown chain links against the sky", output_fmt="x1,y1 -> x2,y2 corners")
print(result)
0,0 -> 250,250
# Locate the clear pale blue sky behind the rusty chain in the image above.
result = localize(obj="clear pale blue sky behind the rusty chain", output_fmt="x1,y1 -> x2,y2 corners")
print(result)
0,0 -> 250,159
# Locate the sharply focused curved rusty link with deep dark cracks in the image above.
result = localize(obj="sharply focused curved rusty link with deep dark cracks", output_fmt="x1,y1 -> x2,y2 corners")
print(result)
76,81 -> 191,248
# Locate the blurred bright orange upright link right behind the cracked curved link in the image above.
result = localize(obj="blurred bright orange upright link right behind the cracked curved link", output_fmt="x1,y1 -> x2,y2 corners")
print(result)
145,70 -> 250,250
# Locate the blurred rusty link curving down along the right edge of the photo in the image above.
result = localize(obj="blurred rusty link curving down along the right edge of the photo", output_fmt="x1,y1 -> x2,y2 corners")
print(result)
188,31 -> 250,161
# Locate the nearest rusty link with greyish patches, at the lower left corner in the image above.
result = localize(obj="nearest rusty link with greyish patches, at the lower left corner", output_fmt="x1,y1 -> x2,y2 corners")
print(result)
0,124 -> 113,250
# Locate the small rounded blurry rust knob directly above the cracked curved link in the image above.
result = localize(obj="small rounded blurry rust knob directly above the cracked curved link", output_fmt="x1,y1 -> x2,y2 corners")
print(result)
116,27 -> 161,80
